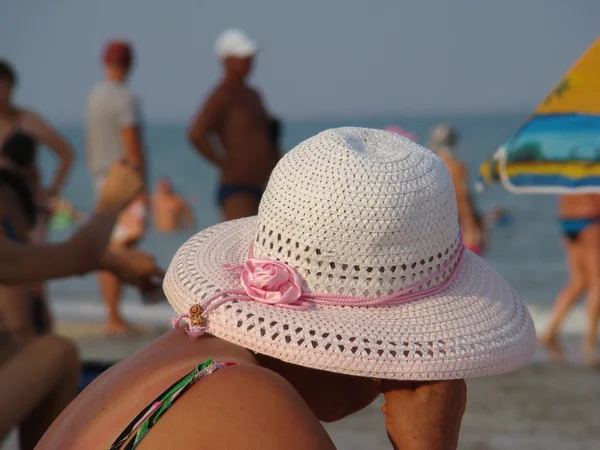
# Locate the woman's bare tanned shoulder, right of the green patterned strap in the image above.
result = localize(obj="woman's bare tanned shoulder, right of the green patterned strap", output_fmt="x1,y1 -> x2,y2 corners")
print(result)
142,364 -> 335,450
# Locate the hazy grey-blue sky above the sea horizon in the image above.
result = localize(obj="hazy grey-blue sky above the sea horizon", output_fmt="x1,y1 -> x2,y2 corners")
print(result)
0,0 -> 600,123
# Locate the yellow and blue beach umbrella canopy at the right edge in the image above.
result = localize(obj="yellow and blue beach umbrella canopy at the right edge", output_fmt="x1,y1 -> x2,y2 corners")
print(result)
479,37 -> 600,194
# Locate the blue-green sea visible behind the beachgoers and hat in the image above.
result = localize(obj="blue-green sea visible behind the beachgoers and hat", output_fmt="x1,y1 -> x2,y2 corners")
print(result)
41,113 -> 585,334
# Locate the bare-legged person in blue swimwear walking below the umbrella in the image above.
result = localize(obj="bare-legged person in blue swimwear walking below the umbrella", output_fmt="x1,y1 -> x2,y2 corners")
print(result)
540,194 -> 600,366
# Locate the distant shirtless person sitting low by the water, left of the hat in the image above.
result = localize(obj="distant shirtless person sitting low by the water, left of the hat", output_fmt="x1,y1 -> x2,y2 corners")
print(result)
152,177 -> 196,233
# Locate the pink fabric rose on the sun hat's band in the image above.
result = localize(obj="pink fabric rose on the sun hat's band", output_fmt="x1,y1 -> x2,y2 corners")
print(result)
240,258 -> 302,305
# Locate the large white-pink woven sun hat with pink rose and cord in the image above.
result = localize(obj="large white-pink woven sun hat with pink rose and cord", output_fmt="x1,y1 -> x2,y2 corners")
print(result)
164,128 -> 535,380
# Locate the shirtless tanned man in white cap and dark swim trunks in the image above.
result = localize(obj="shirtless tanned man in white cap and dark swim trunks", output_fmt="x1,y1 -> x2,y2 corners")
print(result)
188,29 -> 278,220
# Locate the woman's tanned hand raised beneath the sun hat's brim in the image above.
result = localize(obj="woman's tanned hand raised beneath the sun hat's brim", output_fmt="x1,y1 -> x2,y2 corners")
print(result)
381,380 -> 467,450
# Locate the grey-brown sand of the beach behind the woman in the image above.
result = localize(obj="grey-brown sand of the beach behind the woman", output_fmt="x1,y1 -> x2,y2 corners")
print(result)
0,322 -> 600,450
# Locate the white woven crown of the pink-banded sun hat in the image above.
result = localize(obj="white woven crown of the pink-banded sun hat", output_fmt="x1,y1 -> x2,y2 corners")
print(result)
253,128 -> 460,296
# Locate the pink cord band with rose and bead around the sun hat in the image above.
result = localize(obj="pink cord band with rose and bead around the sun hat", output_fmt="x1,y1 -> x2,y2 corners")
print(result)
171,235 -> 465,339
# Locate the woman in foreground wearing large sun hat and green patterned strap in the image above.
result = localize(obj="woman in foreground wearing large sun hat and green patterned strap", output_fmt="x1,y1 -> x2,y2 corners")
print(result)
37,128 -> 535,450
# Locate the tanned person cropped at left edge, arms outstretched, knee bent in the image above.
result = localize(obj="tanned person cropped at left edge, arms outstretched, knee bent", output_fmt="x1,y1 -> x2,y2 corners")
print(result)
0,163 -> 162,449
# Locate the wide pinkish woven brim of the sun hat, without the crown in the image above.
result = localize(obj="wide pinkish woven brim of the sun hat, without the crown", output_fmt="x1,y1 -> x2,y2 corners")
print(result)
164,217 -> 535,380
